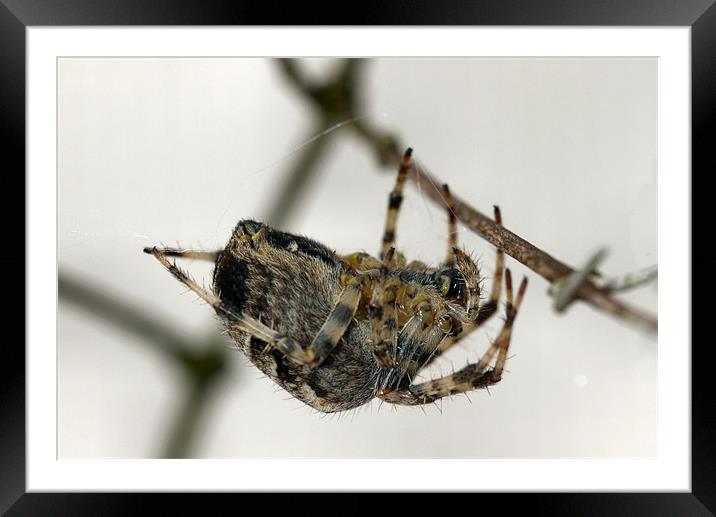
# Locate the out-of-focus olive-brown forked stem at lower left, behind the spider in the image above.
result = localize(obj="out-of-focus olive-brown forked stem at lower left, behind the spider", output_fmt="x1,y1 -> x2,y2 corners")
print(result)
58,271 -> 227,458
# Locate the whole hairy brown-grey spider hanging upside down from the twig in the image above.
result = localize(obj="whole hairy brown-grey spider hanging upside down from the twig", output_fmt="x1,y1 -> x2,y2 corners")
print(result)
144,148 -> 527,413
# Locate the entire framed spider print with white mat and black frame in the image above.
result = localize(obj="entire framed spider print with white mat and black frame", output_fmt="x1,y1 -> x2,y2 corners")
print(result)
3,2 -> 716,514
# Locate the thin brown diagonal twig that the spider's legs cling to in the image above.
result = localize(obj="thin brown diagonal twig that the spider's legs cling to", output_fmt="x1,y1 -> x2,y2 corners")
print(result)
279,59 -> 658,333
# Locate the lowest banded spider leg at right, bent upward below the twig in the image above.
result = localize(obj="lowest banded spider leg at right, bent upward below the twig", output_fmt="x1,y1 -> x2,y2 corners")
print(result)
378,270 -> 527,405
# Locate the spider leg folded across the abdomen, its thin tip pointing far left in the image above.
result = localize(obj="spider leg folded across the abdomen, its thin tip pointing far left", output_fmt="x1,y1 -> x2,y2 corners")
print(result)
151,248 -> 362,368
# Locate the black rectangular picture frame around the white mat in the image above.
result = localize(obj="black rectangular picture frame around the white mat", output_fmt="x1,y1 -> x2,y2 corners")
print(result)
0,0 -> 716,515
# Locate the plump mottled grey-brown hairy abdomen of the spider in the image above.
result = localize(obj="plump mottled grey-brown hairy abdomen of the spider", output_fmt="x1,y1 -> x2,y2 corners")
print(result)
214,221 -> 380,412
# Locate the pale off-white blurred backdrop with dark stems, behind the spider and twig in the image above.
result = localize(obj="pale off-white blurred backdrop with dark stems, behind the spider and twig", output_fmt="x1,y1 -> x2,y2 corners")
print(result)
57,58 -> 657,458
